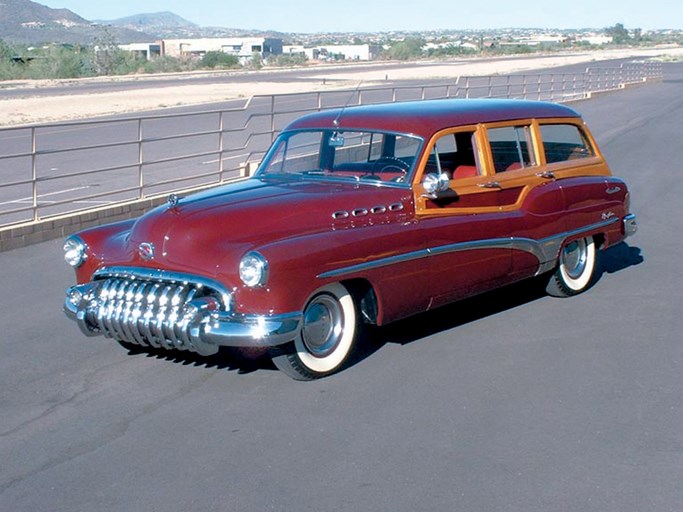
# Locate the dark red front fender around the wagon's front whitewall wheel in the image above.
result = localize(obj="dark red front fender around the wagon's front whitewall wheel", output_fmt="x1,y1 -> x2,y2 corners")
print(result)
230,223 -> 427,318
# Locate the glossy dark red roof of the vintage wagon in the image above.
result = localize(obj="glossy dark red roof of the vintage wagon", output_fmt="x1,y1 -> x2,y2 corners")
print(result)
285,99 -> 580,138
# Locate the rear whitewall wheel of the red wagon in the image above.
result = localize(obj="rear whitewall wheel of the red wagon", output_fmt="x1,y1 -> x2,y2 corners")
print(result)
546,236 -> 596,297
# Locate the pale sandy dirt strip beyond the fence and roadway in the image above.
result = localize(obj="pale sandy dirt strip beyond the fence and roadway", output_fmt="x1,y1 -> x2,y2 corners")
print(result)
0,48 -> 683,127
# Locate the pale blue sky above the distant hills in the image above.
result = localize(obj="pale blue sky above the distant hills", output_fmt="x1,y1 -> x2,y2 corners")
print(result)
37,0 -> 683,33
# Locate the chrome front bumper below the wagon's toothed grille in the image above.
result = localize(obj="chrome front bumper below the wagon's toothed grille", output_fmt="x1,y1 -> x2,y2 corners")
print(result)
64,283 -> 302,355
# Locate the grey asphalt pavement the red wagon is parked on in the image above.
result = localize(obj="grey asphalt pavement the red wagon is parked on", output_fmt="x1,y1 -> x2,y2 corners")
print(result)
0,64 -> 683,512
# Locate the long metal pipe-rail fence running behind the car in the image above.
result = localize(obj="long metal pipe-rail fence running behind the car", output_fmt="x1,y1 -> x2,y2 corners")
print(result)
0,62 -> 662,231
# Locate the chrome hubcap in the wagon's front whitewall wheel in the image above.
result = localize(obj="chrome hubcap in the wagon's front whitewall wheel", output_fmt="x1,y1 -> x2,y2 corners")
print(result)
301,295 -> 344,357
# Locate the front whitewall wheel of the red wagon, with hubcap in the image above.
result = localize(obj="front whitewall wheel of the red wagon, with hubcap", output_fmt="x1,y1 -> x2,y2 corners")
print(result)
273,283 -> 358,380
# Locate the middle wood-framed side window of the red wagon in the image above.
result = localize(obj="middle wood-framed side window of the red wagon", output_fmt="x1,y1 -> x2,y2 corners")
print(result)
487,125 -> 537,173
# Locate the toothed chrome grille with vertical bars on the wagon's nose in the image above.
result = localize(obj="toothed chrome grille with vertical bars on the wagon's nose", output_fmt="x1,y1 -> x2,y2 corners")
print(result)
85,275 -> 223,351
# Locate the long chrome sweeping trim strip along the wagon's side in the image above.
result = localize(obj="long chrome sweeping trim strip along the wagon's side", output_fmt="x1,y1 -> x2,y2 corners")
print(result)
317,219 -> 619,279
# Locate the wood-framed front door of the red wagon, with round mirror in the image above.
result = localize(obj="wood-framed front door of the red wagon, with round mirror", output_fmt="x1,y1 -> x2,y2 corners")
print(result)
416,127 -> 511,307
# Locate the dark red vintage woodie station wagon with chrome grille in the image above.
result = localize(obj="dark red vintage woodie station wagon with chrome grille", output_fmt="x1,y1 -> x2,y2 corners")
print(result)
64,99 -> 636,380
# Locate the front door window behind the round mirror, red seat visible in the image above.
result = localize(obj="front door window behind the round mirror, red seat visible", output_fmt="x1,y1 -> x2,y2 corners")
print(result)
425,131 -> 479,179
